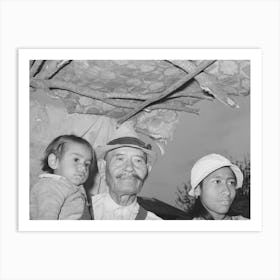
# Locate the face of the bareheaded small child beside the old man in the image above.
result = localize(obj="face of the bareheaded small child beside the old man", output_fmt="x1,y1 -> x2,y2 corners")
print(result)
54,142 -> 92,186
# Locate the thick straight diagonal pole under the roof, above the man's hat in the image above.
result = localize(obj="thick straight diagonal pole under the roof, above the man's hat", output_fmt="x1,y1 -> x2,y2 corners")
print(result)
118,60 -> 215,124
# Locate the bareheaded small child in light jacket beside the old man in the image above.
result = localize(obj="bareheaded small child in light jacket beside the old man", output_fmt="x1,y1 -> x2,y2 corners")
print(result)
30,135 -> 95,220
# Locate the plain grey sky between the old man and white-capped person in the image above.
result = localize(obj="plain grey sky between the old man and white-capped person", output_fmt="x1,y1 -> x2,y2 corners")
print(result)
140,96 -> 250,207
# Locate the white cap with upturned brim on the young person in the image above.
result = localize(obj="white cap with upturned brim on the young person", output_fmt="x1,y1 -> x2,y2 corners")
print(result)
189,154 -> 243,196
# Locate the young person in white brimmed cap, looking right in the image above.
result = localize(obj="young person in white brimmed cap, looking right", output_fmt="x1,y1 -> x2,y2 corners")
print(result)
189,154 -> 246,220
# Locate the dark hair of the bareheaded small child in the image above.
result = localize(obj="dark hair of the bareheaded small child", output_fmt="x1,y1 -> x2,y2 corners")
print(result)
41,134 -> 95,174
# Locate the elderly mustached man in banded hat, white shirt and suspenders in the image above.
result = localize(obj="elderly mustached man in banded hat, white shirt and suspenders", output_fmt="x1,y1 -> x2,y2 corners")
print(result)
92,126 -> 161,220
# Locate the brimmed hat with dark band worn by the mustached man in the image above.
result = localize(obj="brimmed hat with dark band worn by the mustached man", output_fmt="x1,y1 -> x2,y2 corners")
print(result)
95,124 -> 156,164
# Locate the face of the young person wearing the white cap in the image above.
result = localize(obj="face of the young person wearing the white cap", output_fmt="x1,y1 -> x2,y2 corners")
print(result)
197,167 -> 236,219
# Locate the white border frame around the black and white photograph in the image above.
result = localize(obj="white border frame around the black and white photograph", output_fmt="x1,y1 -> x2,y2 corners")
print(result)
18,49 -> 262,231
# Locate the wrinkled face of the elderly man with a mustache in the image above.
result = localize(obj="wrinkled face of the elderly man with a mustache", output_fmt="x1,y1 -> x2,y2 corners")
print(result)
105,147 -> 149,195
